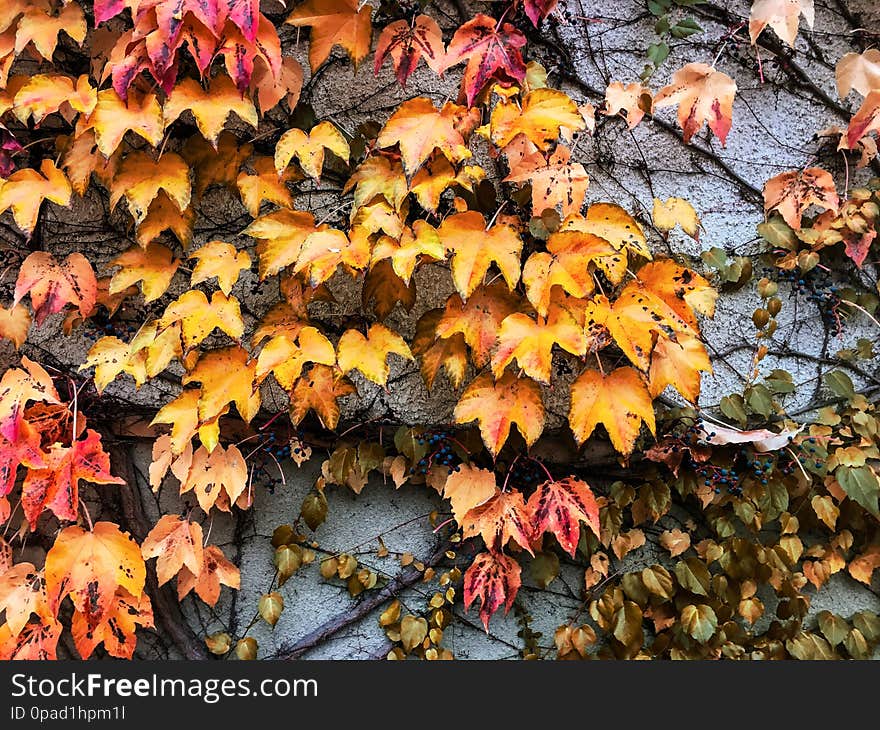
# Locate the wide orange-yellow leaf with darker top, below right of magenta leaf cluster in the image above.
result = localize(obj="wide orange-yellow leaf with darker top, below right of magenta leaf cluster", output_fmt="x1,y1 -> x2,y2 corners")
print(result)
162,74 -> 259,146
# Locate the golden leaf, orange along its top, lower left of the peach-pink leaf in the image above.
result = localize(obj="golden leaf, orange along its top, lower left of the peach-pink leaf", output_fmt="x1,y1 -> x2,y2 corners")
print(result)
438,210 -> 522,299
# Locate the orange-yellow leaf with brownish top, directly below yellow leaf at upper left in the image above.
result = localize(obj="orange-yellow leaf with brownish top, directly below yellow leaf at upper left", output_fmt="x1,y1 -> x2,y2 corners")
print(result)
110,152 -> 192,225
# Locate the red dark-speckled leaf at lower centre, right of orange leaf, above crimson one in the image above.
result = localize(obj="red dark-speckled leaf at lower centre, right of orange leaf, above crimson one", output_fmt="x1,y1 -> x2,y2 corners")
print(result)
527,477 -> 599,558
